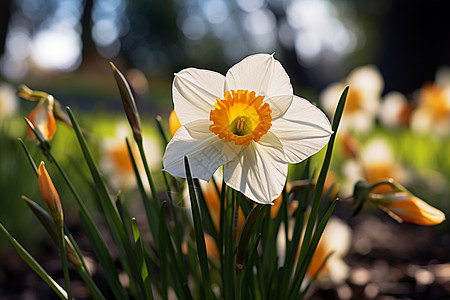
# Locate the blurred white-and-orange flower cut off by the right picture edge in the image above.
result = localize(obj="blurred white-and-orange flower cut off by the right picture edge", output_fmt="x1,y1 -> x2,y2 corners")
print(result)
411,68 -> 450,135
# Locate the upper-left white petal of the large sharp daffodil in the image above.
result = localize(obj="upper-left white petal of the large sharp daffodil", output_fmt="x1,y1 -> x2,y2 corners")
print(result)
172,68 -> 225,125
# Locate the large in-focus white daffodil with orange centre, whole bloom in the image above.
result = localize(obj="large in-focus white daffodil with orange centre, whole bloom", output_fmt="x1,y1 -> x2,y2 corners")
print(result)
163,54 -> 332,204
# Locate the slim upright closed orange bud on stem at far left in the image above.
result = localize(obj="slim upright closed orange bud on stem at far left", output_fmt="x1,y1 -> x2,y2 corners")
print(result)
38,161 -> 64,227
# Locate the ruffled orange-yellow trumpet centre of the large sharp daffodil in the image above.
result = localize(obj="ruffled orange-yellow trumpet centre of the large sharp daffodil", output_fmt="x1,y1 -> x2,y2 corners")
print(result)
209,90 -> 272,146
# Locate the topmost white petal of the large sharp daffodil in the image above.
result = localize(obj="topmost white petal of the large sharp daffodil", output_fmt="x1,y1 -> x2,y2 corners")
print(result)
225,54 -> 293,98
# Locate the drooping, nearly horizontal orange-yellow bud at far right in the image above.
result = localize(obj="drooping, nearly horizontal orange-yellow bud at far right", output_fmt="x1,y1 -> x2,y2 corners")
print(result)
369,192 -> 445,225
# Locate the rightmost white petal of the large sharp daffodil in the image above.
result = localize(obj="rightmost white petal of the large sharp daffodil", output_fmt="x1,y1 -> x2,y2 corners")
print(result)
270,96 -> 332,163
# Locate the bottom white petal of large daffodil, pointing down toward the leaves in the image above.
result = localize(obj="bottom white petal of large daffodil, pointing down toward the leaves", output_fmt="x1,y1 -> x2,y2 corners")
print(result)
224,133 -> 287,204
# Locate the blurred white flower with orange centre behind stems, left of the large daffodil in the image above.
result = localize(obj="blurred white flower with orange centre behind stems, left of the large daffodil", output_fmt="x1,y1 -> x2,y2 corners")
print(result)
99,124 -> 162,189
